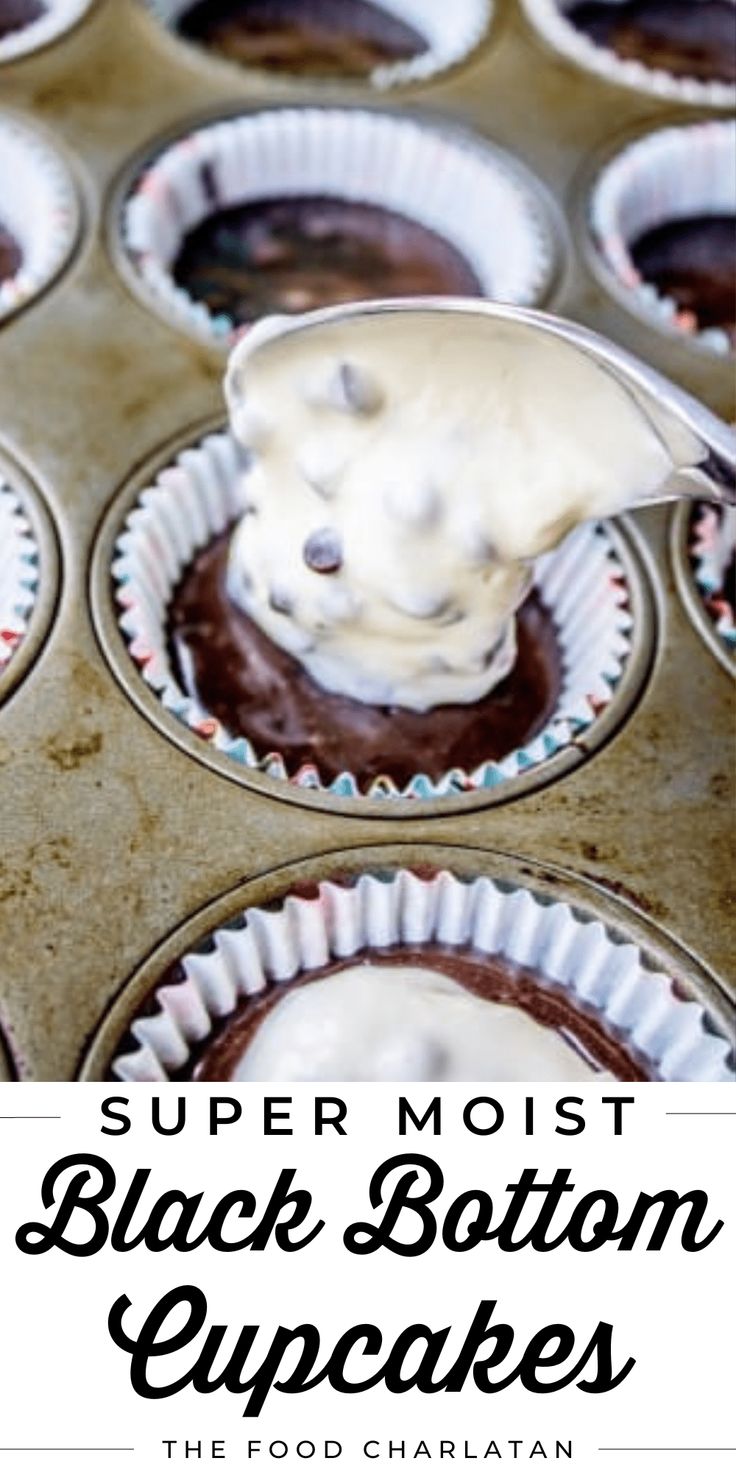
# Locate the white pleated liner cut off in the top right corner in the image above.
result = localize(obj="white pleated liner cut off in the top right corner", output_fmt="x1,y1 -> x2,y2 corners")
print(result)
521,0 -> 736,107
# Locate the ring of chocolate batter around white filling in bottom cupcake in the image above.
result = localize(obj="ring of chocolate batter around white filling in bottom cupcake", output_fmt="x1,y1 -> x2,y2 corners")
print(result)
186,944 -> 651,1083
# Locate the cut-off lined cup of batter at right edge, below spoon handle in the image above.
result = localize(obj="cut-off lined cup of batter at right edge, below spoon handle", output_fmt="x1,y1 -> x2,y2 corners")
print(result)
671,502 -> 736,676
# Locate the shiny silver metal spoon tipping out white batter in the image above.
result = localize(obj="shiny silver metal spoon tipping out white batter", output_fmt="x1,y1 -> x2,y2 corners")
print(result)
238,296 -> 736,506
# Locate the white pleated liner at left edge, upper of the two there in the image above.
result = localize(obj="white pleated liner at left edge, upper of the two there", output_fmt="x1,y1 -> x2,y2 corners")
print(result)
0,113 -> 79,321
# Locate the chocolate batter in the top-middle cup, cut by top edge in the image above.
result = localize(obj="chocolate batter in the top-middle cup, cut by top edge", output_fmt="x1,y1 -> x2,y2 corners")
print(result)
178,0 -> 427,77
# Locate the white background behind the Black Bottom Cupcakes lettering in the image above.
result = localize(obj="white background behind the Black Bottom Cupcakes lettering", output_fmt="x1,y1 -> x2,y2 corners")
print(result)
0,1085 -> 736,1472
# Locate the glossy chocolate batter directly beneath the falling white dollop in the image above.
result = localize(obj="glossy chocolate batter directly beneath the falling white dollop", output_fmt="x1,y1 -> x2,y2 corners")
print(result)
169,533 -> 562,788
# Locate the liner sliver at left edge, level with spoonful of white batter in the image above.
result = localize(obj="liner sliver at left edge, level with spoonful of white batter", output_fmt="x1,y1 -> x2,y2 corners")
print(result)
0,449 -> 59,704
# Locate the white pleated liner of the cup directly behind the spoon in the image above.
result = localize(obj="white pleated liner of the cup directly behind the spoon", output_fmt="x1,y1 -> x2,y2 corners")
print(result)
121,106 -> 555,344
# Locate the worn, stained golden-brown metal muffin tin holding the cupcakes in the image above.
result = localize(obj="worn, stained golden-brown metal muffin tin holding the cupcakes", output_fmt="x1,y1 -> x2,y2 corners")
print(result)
0,0 -> 735,1079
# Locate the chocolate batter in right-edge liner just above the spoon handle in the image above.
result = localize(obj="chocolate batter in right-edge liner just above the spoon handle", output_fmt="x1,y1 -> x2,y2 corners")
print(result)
630,215 -> 736,342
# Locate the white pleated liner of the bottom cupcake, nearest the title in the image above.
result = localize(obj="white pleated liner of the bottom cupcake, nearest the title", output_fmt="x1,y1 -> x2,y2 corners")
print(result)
112,868 -> 736,1083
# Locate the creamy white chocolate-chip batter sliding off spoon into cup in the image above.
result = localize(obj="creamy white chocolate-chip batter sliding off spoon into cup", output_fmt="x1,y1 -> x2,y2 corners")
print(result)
225,311 -> 673,710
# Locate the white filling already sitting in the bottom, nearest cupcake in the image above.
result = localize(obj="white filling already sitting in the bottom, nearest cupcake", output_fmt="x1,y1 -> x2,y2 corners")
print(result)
231,961 -> 609,1083
